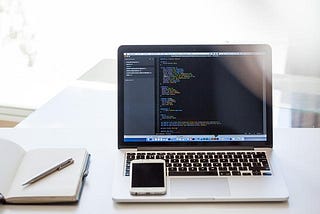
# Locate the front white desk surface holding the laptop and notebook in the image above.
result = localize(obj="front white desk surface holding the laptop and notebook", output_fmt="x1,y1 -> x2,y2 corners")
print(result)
0,128 -> 320,214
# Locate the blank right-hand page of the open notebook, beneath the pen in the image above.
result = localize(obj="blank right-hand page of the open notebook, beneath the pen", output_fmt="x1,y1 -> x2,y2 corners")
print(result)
7,148 -> 87,201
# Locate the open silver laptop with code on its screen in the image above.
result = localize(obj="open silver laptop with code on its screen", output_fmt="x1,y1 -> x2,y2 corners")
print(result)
112,44 -> 289,202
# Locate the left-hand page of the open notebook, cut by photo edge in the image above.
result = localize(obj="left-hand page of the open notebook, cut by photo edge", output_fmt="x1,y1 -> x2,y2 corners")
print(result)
0,139 -> 25,196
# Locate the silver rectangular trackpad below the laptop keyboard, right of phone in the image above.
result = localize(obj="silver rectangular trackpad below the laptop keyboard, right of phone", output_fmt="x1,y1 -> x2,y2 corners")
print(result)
170,178 -> 230,198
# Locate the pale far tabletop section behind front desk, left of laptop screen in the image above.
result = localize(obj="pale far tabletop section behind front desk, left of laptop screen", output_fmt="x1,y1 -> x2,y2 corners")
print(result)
16,80 -> 117,128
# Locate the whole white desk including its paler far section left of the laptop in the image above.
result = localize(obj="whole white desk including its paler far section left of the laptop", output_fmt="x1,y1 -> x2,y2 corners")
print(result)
0,83 -> 320,214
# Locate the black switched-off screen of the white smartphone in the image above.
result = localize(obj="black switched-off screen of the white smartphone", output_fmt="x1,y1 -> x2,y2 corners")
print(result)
131,163 -> 165,188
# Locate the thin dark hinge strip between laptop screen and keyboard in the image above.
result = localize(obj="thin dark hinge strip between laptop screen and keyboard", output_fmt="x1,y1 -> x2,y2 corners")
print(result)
137,146 -> 254,151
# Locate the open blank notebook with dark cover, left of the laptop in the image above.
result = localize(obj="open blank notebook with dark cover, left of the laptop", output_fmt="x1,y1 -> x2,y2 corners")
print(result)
0,139 -> 90,204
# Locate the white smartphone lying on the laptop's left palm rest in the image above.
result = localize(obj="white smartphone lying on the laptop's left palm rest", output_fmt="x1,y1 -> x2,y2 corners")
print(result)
130,159 -> 167,195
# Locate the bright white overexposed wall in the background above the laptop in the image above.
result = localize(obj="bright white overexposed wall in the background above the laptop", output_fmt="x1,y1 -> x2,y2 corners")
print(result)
0,0 -> 320,107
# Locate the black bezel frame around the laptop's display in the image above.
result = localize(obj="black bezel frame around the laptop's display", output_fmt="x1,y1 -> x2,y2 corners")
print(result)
118,44 -> 273,149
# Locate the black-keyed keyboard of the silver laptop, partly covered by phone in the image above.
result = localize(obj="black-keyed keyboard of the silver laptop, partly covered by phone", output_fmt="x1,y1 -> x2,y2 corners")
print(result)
125,151 -> 272,176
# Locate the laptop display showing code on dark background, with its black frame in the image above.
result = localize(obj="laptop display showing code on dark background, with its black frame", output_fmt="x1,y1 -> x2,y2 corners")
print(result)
119,45 -> 271,146
